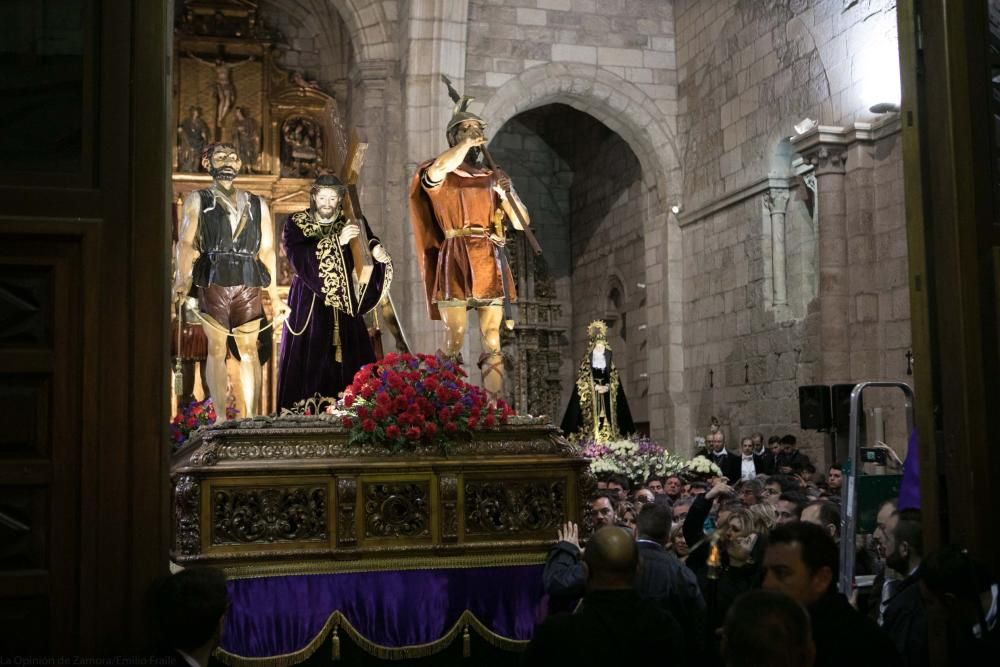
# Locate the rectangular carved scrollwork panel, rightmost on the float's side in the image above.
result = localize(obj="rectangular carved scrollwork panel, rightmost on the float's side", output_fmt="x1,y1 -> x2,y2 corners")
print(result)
465,479 -> 566,536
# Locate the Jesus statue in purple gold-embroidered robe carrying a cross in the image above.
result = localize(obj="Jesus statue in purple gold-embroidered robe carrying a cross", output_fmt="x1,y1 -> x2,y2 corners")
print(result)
278,176 -> 392,408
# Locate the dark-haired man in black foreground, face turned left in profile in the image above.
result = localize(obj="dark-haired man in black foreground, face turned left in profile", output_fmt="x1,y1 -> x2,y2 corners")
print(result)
763,521 -> 903,667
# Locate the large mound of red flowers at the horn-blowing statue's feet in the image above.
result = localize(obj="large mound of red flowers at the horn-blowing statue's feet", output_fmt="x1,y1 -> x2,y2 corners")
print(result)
342,354 -> 514,450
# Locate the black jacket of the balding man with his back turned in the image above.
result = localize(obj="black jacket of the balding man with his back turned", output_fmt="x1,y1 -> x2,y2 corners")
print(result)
522,589 -> 684,667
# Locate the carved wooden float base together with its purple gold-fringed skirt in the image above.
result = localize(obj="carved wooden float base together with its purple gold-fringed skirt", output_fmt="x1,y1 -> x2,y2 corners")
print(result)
171,415 -> 593,665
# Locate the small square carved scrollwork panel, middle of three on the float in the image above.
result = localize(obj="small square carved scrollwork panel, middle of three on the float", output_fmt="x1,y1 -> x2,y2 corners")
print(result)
364,482 -> 431,538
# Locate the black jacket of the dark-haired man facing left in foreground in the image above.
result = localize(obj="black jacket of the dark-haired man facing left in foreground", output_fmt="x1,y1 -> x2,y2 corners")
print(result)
809,587 -> 904,667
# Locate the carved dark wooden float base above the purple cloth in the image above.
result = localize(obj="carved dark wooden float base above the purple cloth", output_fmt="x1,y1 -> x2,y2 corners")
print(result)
171,416 -> 593,574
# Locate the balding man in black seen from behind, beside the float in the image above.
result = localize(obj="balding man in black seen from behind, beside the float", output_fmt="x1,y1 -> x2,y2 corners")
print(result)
523,526 -> 684,667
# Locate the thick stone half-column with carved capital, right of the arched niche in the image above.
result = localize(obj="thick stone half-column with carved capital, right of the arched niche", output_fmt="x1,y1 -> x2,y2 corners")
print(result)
792,126 -> 851,384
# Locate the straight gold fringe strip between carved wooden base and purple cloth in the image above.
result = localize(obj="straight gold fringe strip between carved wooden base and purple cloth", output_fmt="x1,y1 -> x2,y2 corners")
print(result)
221,553 -> 545,579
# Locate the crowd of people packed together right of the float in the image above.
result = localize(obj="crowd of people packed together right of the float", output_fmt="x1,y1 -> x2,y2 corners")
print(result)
524,431 -> 1000,667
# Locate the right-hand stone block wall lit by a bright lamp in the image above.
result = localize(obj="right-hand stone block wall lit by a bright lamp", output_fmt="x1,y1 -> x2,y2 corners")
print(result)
675,0 -> 910,460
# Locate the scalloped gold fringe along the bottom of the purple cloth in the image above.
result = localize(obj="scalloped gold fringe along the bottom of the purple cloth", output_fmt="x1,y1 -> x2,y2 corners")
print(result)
215,609 -> 528,667
